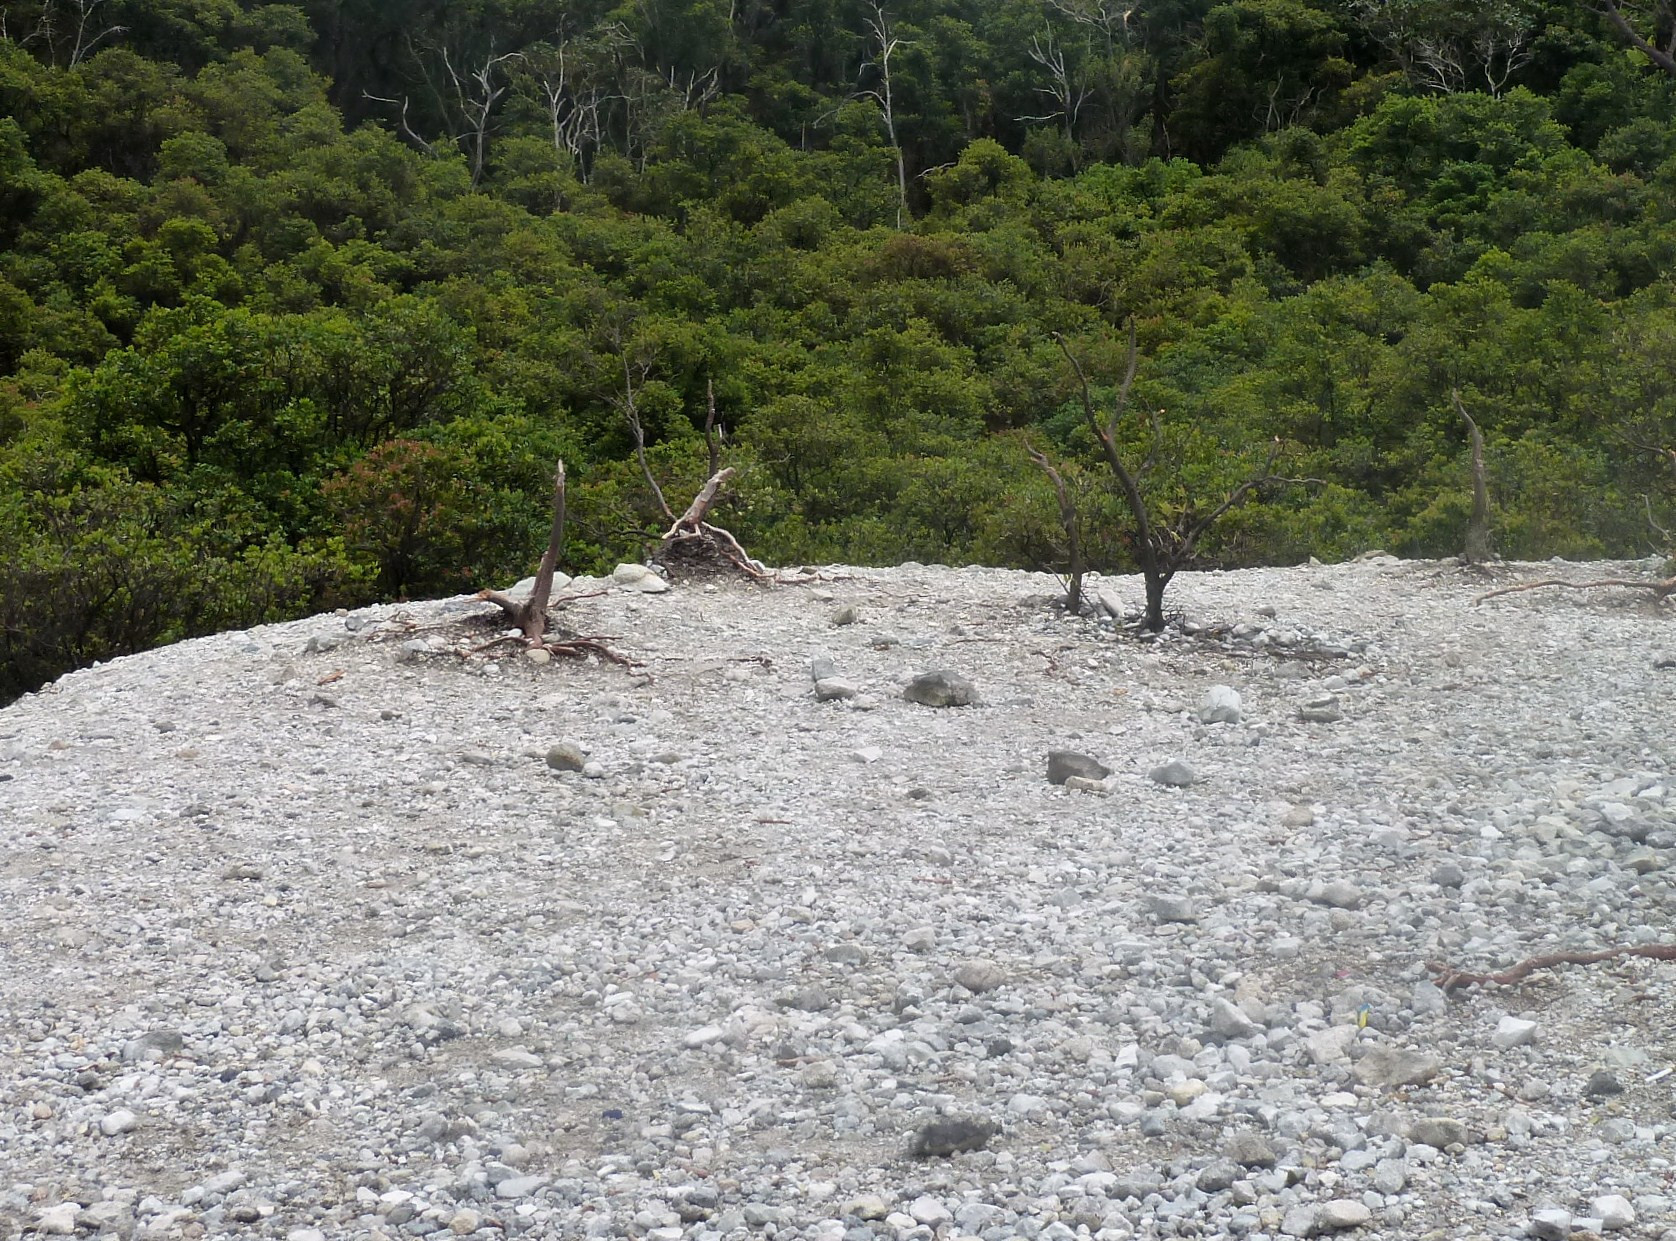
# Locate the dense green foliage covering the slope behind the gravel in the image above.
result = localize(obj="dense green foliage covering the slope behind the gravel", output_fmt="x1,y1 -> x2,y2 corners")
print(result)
0,0 -> 1676,701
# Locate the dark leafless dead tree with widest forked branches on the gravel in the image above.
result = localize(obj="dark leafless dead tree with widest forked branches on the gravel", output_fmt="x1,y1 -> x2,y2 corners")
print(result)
1054,319 -> 1280,634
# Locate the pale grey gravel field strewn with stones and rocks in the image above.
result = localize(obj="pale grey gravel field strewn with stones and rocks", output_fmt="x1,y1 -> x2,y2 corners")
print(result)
0,555 -> 1676,1241
